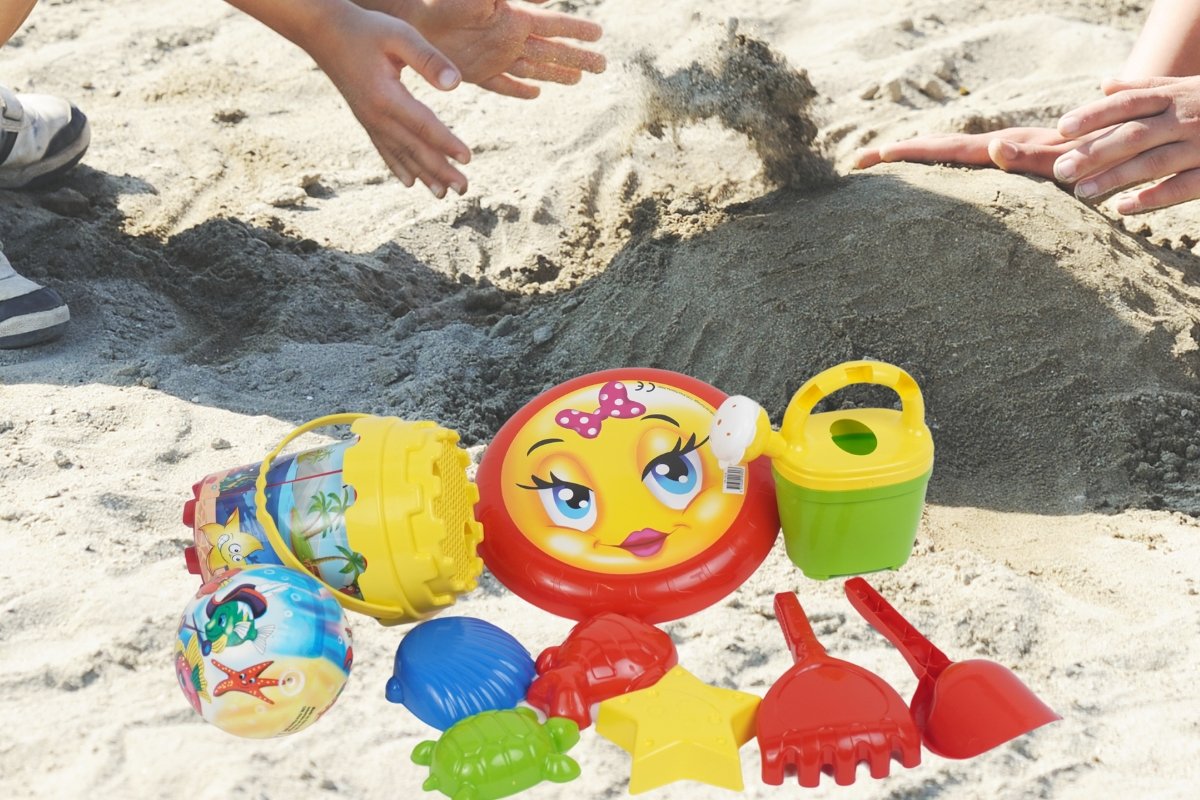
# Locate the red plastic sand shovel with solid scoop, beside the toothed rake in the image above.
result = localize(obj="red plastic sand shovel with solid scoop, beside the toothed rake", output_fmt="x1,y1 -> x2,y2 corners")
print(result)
846,578 -> 1062,758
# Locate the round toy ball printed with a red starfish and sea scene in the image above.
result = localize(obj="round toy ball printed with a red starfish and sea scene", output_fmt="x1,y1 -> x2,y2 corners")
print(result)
175,566 -> 353,739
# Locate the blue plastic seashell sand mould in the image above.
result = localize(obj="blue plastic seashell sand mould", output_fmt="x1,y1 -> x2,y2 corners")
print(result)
385,616 -> 535,730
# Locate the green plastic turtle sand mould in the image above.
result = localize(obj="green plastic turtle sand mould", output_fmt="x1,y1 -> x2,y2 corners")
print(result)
413,708 -> 580,800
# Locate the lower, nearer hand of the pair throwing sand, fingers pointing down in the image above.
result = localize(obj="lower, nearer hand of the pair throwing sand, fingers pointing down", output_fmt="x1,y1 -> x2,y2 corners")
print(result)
300,4 -> 470,198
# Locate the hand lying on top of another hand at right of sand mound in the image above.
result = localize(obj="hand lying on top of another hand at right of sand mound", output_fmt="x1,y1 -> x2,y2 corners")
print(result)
1055,77 -> 1200,213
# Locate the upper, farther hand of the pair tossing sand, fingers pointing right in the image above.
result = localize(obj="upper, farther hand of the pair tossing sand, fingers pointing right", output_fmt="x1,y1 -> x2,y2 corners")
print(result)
356,0 -> 605,98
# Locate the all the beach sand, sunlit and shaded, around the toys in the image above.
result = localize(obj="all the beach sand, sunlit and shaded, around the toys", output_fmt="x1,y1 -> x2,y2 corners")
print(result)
0,0 -> 1200,800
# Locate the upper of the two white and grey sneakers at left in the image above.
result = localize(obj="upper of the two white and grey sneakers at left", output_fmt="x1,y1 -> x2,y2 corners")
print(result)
0,86 -> 91,188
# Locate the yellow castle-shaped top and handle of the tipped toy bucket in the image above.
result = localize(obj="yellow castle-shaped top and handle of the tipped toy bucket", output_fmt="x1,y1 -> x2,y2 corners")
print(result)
241,414 -> 482,625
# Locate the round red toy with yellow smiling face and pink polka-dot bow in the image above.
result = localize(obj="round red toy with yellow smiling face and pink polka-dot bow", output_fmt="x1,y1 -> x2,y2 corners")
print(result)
476,368 -> 779,622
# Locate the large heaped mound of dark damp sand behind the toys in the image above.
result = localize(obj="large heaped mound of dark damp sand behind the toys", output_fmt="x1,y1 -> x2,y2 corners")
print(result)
526,168 -> 1200,513
